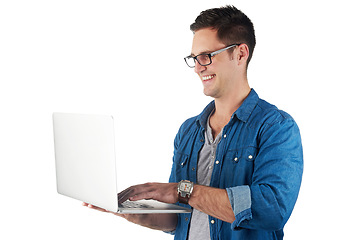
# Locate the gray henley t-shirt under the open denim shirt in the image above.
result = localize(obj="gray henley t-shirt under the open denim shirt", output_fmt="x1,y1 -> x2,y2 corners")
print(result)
188,113 -> 223,240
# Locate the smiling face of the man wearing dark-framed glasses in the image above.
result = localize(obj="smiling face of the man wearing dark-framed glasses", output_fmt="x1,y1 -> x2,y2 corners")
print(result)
191,28 -> 236,98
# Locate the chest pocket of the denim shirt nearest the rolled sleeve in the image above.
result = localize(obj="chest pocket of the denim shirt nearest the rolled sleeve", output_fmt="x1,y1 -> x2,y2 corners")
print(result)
222,147 -> 258,187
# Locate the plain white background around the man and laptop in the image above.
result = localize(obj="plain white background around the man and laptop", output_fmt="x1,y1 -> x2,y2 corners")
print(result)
0,0 -> 360,239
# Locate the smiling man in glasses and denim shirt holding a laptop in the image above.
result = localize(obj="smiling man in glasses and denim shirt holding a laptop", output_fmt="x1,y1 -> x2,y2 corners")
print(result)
85,6 -> 303,239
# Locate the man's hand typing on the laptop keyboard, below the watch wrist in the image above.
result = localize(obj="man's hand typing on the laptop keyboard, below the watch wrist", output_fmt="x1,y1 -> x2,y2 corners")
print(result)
118,183 -> 178,203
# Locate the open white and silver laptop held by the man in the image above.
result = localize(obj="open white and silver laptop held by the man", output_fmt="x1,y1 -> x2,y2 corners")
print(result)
53,113 -> 191,214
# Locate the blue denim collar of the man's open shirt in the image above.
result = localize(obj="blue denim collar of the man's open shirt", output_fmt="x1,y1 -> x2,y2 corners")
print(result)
196,89 -> 259,129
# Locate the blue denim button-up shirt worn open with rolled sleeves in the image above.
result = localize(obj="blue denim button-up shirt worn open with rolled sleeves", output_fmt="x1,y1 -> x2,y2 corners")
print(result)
169,89 -> 303,240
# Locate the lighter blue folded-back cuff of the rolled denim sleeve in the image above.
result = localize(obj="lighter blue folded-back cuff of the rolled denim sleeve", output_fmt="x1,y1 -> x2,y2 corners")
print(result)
226,185 -> 252,229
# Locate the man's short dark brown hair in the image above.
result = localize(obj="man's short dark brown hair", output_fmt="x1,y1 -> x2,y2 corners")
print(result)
190,5 -> 256,63
